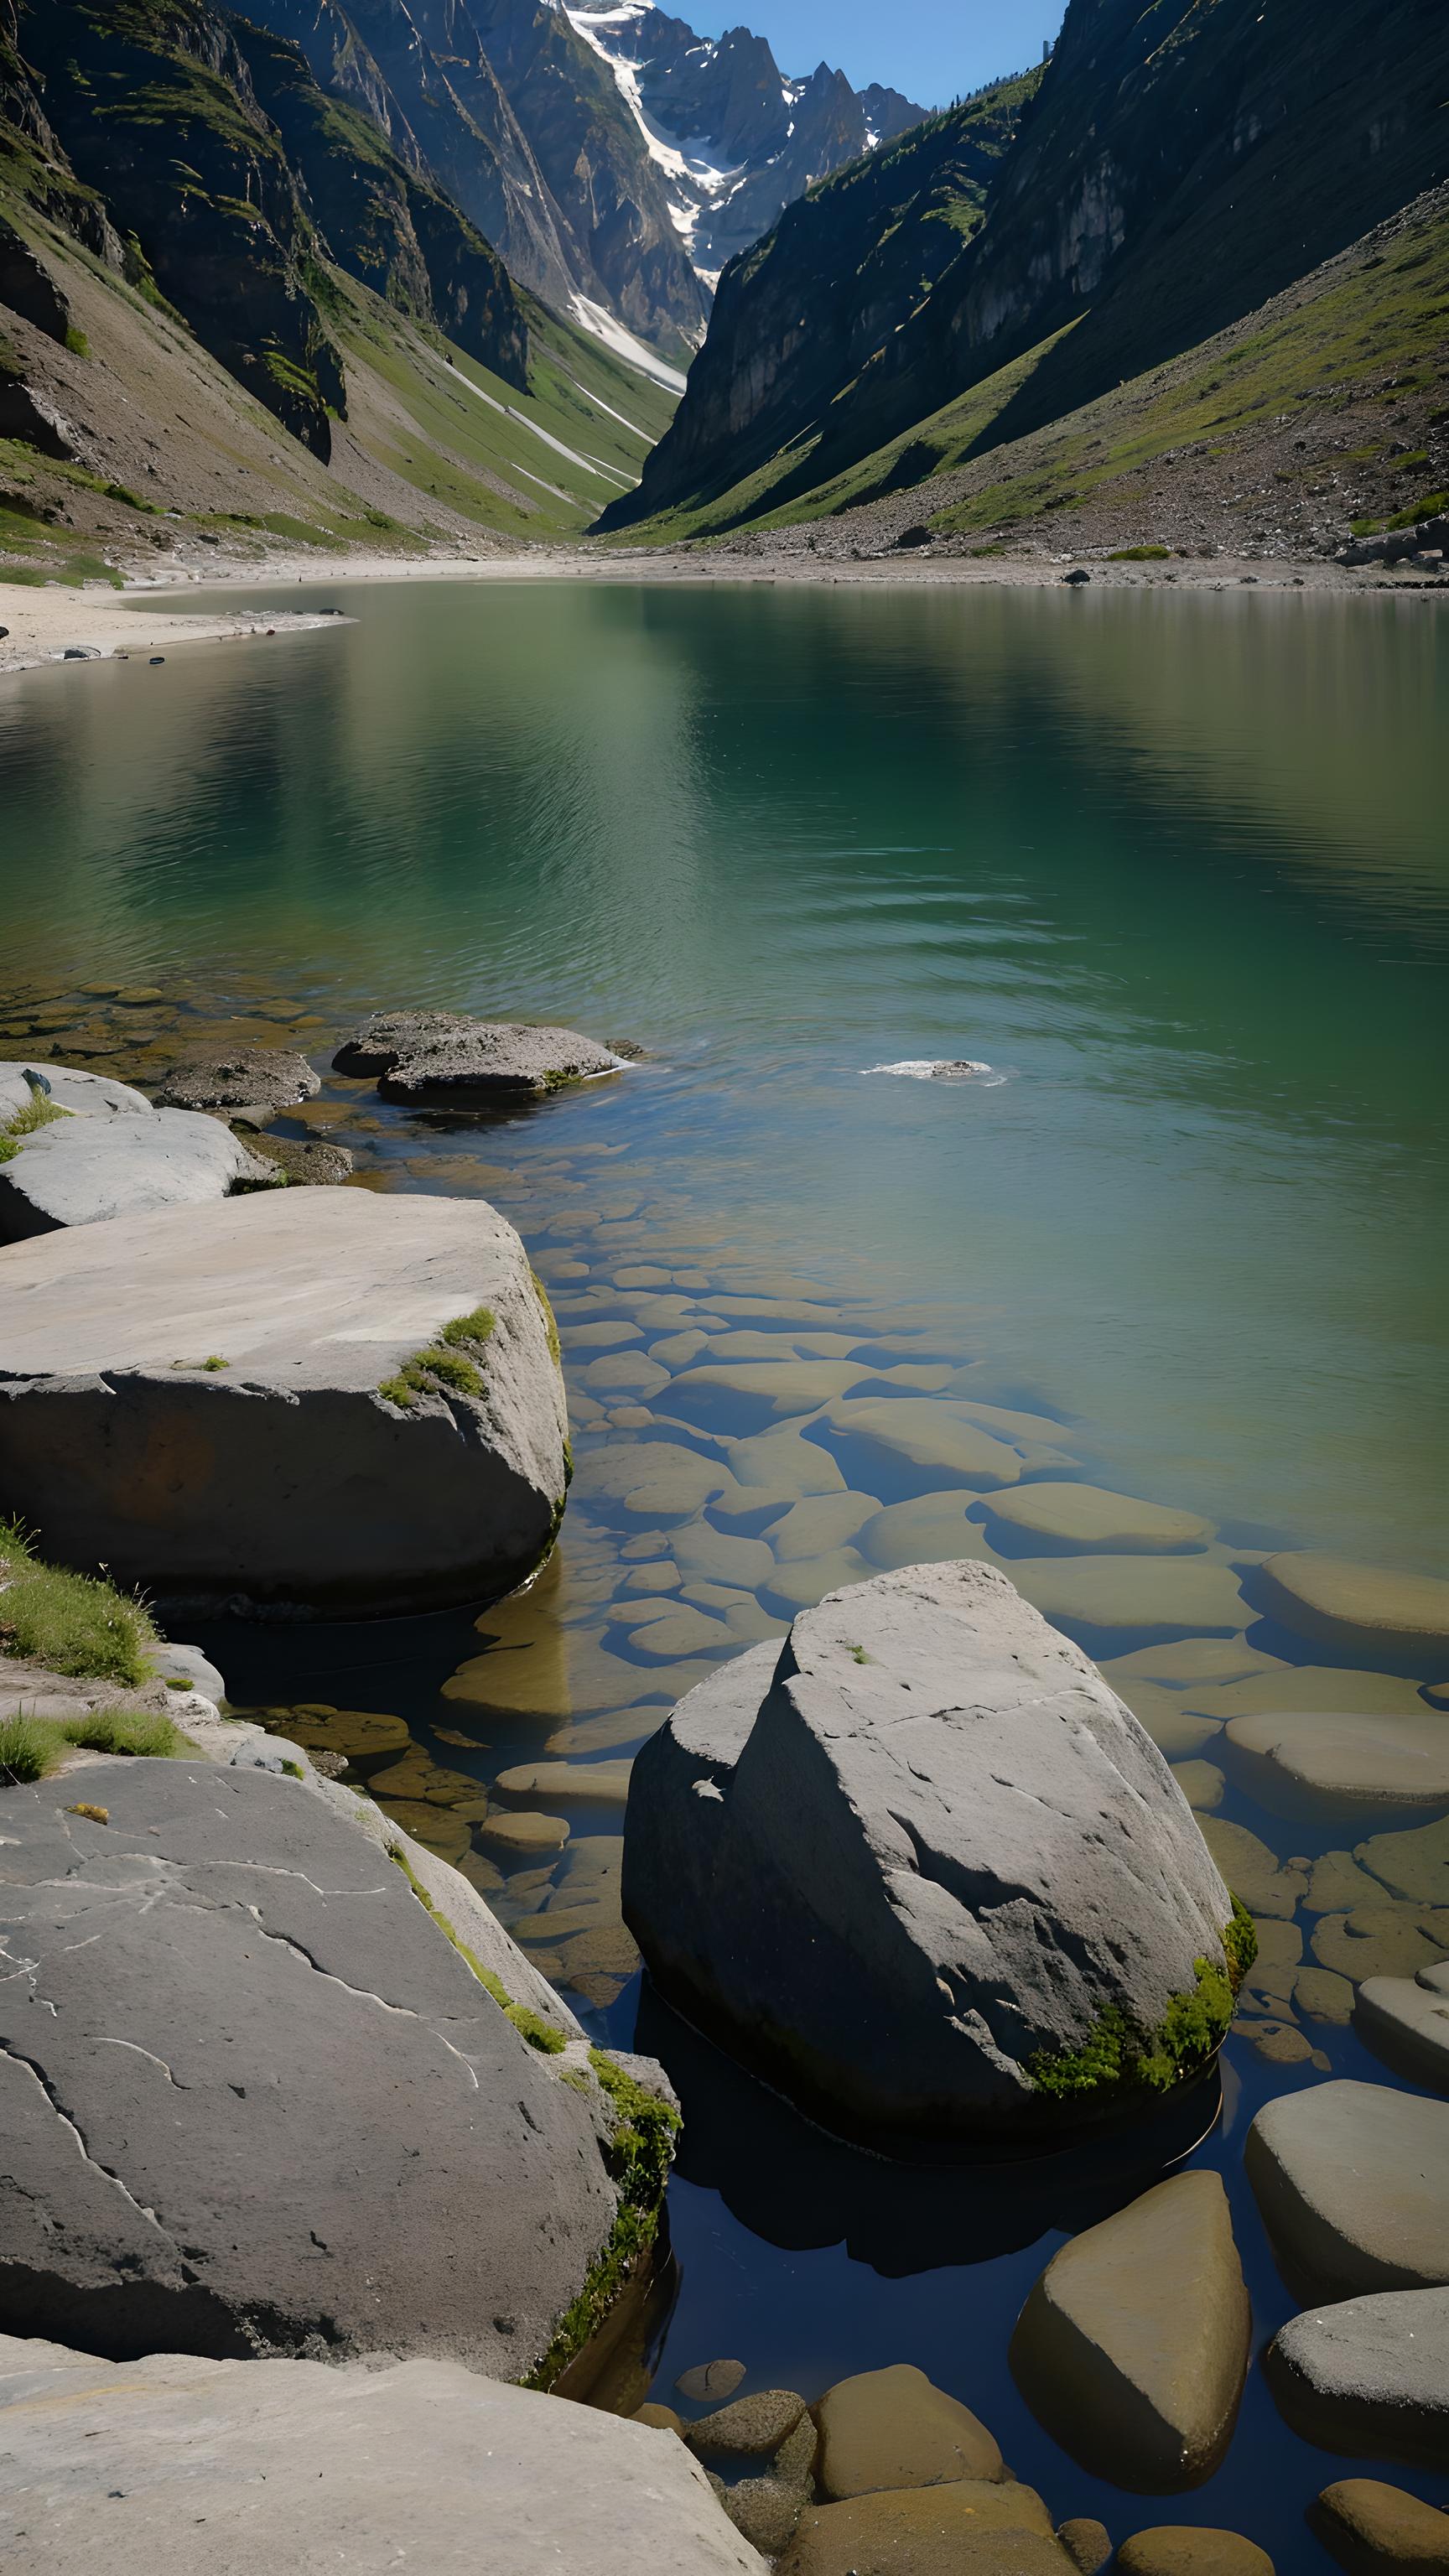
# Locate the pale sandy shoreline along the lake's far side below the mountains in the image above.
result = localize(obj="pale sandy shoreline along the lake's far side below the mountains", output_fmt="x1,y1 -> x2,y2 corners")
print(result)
0,546 -> 1449,673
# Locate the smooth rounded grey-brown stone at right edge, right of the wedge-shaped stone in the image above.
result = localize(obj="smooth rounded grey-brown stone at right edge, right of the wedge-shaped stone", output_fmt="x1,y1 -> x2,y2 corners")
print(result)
1245,2081 -> 1449,2298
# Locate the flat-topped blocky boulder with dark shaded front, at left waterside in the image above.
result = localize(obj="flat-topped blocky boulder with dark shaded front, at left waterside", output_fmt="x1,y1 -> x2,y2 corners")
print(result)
0,1185 -> 567,1615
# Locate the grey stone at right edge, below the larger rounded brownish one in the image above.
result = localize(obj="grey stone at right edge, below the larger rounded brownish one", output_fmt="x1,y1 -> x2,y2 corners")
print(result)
1264,2290 -> 1449,2470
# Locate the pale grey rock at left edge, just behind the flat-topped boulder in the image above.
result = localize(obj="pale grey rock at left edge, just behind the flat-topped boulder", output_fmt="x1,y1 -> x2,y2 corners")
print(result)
0,1108 -> 273,1244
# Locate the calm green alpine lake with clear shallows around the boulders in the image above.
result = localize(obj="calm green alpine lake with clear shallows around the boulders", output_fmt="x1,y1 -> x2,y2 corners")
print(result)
0,579 -> 1449,2576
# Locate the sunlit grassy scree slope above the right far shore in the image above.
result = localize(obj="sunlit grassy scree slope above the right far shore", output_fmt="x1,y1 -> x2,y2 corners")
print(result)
618,185 -> 1449,557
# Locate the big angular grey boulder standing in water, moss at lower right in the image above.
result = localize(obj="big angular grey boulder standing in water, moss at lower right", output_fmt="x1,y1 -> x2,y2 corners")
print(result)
613,1564 -> 1233,2153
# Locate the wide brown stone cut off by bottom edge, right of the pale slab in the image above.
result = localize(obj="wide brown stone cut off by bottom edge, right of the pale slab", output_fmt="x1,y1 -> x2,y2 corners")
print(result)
779,2478 -> 1072,2576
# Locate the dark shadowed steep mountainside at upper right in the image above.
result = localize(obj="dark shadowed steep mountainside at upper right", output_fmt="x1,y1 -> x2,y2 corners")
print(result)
600,0 -> 1449,531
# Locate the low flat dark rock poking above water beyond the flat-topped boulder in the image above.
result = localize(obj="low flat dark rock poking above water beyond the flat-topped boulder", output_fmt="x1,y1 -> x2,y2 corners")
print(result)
333,1010 -> 631,1105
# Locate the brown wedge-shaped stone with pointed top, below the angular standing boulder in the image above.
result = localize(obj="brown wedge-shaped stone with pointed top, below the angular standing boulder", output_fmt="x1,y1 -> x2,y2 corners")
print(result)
1010,2172 -> 1253,2494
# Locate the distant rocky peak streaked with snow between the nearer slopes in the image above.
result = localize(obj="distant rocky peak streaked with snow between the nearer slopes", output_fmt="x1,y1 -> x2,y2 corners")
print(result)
231,0 -> 921,358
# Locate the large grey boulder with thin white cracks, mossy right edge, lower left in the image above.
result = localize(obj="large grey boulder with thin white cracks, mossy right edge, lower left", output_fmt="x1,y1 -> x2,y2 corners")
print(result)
0,1759 -> 665,2381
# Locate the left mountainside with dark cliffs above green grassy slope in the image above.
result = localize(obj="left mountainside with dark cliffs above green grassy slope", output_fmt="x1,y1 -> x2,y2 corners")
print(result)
0,0 -> 673,579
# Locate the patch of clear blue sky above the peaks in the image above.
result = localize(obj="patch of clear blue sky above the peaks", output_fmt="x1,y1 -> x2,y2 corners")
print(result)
696,0 -> 1062,108
